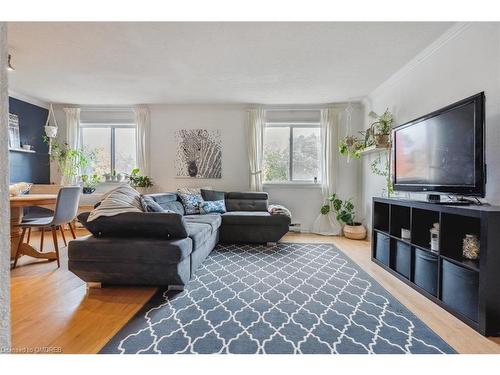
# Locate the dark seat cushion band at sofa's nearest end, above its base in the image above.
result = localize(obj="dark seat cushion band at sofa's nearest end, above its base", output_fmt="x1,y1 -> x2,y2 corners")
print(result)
68,236 -> 192,264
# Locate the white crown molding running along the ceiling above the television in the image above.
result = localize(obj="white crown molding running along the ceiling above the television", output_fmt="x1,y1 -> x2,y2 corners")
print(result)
367,22 -> 472,97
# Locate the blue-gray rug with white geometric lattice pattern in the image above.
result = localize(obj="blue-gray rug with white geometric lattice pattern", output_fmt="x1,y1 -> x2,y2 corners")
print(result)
101,243 -> 455,354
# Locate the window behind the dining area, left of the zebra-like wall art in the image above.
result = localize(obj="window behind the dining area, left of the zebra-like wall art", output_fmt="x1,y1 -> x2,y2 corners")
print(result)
80,124 -> 137,175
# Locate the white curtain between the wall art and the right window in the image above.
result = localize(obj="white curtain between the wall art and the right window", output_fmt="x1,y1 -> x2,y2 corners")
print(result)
246,108 -> 266,191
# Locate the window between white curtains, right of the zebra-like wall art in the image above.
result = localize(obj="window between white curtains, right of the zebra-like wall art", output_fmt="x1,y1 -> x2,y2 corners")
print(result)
263,123 -> 321,182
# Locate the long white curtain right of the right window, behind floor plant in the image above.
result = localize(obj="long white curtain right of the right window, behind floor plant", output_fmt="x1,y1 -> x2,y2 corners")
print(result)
312,108 -> 342,235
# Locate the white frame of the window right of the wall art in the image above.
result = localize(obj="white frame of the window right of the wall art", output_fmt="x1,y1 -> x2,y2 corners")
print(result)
262,121 -> 323,185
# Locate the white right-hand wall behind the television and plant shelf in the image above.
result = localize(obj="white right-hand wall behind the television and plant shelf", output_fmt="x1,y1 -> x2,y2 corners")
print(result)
362,23 -> 500,232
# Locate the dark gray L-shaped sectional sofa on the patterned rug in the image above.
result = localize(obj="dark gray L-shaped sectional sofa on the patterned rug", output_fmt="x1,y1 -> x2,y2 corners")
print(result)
68,191 -> 290,288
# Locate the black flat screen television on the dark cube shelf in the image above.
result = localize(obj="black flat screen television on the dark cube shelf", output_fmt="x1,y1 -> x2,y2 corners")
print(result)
392,92 -> 486,197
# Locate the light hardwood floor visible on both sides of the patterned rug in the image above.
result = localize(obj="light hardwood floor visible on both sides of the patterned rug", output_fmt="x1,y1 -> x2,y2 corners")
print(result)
11,230 -> 500,353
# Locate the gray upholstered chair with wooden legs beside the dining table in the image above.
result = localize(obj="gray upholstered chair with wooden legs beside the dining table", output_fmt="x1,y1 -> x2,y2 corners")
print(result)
14,186 -> 82,268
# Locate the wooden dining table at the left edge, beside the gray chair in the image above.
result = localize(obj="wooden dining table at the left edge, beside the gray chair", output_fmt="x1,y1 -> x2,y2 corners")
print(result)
10,194 -> 57,261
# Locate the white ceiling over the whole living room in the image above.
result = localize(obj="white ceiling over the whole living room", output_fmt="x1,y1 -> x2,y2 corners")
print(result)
8,22 -> 452,105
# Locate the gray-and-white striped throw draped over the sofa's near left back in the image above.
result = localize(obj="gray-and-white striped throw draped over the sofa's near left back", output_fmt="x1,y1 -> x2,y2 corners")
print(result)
87,185 -> 143,221
